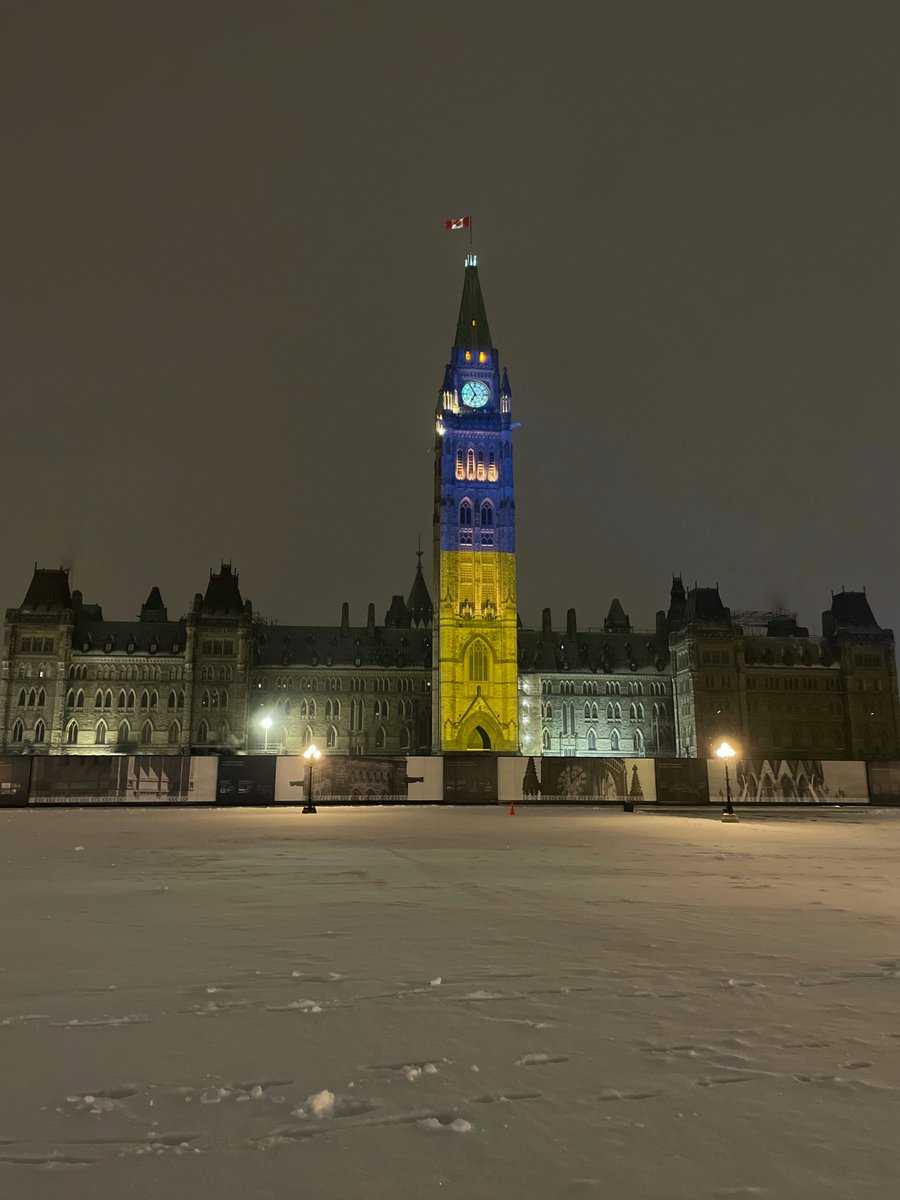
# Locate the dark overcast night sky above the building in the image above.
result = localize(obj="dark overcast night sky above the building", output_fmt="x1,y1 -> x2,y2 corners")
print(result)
0,0 -> 900,632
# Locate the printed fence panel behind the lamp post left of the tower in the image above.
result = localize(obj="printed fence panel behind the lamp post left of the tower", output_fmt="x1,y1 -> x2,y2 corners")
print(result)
270,755 -> 443,805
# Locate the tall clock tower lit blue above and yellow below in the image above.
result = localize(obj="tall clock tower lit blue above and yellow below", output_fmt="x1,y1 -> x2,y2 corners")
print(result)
432,254 -> 518,754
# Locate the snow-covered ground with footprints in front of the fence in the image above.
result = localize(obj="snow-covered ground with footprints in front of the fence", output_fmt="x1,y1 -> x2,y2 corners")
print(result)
0,808 -> 900,1200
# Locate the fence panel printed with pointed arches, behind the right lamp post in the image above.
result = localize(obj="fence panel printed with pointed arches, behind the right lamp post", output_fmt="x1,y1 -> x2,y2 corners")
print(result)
707,758 -> 869,804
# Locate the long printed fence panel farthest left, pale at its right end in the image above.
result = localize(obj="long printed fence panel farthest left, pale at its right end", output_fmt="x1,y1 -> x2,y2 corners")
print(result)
28,755 -> 217,804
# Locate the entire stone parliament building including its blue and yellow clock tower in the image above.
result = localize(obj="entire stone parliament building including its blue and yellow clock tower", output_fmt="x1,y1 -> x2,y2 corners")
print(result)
0,261 -> 900,760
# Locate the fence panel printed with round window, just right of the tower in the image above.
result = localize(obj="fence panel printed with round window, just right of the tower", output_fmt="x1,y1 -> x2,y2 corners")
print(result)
497,756 -> 656,804
